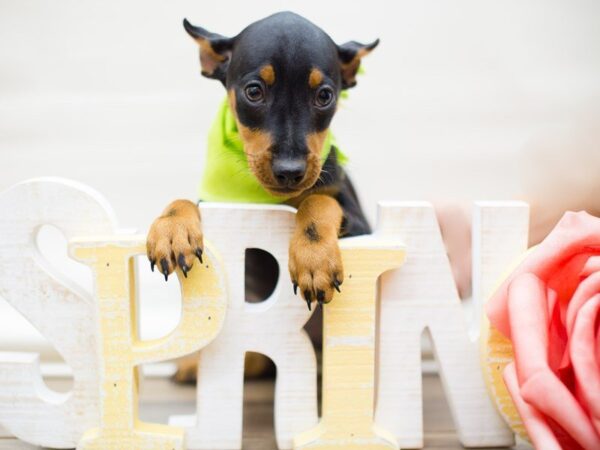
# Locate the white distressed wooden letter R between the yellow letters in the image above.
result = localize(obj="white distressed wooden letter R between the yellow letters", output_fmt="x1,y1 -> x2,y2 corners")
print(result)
171,204 -> 318,450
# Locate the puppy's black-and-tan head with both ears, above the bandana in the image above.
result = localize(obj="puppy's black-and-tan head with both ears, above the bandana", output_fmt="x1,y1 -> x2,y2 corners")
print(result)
183,12 -> 379,197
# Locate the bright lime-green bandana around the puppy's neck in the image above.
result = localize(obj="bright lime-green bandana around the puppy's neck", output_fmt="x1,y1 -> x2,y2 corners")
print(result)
199,99 -> 347,203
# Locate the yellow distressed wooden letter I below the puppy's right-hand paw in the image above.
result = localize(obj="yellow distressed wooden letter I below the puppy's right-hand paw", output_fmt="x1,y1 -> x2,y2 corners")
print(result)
294,238 -> 404,450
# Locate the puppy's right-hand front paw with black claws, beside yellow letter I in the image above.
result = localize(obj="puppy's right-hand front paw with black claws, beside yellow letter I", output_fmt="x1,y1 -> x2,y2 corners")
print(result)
289,222 -> 344,309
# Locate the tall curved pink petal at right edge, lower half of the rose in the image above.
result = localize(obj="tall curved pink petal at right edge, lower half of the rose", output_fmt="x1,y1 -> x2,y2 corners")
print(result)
569,294 -> 600,436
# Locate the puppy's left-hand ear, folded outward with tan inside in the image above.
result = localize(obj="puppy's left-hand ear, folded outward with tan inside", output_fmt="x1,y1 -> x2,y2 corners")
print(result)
183,19 -> 234,84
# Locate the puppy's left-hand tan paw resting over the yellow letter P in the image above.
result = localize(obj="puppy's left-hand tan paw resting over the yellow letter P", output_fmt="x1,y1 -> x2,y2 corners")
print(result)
146,200 -> 204,281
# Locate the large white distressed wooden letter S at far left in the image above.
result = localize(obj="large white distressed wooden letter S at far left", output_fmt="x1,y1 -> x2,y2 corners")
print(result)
0,178 -> 116,448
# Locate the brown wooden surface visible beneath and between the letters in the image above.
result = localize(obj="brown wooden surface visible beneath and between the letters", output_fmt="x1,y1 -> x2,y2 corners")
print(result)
0,374 -> 530,450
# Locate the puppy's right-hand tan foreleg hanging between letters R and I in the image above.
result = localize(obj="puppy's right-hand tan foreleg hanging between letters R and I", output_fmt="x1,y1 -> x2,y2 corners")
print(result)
289,195 -> 344,308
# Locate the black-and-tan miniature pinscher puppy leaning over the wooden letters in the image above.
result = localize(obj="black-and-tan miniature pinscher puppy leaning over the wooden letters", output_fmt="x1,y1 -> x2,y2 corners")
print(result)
147,12 -> 379,308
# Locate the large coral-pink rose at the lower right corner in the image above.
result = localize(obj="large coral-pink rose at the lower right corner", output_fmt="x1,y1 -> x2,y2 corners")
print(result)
486,212 -> 600,450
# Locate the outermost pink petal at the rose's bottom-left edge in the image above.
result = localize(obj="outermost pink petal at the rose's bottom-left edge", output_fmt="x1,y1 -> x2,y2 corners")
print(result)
502,363 -> 562,450
